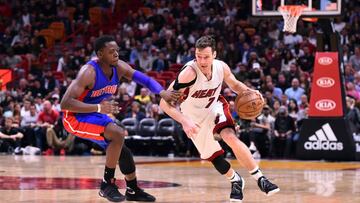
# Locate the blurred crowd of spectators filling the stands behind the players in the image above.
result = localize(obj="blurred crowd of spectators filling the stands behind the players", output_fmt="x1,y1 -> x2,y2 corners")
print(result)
0,0 -> 360,158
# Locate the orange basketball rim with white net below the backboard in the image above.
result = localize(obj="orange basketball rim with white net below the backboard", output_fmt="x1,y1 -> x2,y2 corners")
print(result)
278,5 -> 306,33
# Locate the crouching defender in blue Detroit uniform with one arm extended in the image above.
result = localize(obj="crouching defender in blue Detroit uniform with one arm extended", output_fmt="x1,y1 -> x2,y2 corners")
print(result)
61,36 -> 180,202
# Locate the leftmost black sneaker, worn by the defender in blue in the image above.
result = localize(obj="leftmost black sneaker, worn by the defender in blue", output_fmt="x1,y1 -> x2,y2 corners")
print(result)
99,178 -> 125,202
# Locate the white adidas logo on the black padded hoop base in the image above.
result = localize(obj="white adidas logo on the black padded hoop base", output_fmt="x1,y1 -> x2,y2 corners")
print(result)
304,123 -> 344,151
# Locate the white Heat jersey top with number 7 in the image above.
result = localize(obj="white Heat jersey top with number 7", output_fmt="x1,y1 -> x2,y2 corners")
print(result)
180,59 -> 224,124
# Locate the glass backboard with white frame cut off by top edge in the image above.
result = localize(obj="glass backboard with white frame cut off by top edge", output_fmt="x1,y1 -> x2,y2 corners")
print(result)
251,0 -> 342,18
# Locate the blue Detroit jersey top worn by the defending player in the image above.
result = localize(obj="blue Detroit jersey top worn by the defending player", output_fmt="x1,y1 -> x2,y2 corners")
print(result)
79,60 -> 120,104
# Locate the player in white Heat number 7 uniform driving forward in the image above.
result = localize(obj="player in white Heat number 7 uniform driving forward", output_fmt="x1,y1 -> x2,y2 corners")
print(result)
160,36 -> 280,202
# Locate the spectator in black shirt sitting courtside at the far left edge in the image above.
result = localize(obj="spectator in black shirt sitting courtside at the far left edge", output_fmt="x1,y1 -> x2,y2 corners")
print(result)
0,117 -> 24,154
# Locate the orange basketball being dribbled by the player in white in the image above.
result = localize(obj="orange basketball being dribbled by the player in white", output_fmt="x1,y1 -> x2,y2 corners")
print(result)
235,90 -> 264,120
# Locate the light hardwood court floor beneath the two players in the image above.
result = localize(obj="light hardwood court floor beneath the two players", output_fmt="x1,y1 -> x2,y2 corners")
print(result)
0,155 -> 360,203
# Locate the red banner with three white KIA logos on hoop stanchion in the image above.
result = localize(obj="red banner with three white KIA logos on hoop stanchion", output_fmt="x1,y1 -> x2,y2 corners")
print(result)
309,52 -> 344,117
